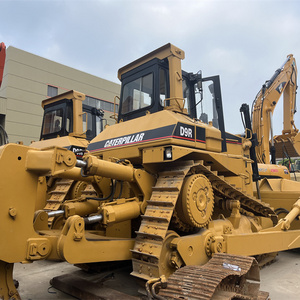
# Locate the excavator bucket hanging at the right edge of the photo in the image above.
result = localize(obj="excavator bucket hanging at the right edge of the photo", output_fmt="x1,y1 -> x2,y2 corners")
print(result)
274,133 -> 300,159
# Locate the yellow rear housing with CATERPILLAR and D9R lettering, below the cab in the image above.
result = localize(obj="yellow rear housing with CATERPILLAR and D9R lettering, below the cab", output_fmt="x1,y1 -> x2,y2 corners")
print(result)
89,110 -> 223,163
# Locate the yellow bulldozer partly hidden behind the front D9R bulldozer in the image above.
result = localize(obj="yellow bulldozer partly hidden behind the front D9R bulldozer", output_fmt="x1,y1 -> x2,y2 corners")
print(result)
30,90 -> 104,228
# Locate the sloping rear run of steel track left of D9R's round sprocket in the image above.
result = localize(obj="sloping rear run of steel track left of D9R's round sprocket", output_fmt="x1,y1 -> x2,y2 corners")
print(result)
131,161 -> 194,280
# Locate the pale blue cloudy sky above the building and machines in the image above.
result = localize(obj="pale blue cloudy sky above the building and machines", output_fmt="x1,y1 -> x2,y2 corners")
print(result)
0,0 -> 300,134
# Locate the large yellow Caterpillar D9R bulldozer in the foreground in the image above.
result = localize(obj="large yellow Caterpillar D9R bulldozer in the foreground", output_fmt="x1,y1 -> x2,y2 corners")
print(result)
0,44 -> 300,299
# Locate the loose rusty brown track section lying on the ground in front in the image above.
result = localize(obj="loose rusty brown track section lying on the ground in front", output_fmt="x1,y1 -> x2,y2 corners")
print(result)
158,253 -> 269,300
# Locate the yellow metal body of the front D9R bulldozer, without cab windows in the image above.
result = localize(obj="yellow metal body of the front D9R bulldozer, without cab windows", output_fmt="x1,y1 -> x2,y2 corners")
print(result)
0,45 -> 300,299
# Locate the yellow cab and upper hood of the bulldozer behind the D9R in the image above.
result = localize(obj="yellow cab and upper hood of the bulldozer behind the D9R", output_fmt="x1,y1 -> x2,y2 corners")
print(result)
30,90 -> 104,158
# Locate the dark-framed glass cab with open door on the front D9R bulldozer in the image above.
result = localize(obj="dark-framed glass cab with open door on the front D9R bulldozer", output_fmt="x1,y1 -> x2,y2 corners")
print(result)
118,58 -> 226,151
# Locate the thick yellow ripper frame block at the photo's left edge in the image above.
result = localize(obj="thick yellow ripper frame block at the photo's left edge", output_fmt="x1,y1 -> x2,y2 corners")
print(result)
0,144 -> 76,263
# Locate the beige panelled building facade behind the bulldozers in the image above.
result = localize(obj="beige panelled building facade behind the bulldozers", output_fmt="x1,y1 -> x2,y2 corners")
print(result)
0,46 -> 120,145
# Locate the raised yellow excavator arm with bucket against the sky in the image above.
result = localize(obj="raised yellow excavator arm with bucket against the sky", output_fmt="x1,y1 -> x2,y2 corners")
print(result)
252,54 -> 300,164
